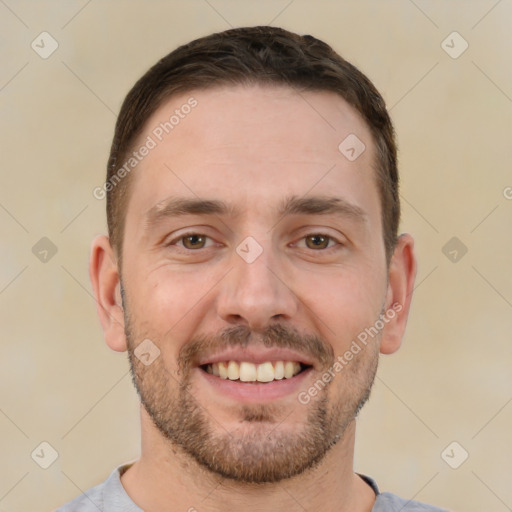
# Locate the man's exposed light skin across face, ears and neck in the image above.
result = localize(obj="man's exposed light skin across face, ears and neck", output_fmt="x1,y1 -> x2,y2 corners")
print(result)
90,86 -> 416,512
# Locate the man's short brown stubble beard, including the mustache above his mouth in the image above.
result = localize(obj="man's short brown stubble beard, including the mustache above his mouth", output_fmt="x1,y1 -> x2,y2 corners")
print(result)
125,309 -> 378,484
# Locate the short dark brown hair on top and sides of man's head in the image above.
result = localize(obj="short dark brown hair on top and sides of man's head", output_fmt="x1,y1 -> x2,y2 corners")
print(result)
107,26 -> 400,262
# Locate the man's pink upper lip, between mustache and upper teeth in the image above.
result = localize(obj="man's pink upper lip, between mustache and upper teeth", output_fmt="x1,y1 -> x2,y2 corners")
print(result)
198,346 -> 313,366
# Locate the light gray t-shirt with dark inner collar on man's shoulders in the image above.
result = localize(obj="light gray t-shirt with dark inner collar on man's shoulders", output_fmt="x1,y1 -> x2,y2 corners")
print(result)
55,464 -> 447,512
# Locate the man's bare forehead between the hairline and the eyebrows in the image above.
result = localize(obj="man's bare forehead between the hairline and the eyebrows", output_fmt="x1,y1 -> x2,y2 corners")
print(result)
127,86 -> 378,224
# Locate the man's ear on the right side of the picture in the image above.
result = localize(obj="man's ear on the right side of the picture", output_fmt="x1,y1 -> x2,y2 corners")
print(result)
380,234 -> 416,354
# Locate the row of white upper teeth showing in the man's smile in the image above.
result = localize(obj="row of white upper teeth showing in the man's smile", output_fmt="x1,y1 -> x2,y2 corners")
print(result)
206,361 -> 301,382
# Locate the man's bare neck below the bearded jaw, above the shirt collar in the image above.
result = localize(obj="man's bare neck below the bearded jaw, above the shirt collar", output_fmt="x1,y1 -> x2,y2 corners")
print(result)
121,406 -> 375,512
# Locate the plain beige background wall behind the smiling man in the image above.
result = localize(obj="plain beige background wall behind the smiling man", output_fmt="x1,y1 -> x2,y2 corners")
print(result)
0,0 -> 512,512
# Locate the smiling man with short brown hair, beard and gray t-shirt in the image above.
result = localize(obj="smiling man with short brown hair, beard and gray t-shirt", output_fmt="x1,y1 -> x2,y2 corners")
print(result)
59,27 -> 448,512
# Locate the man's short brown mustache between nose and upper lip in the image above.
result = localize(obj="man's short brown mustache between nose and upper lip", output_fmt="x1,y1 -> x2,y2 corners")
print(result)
178,324 -> 334,375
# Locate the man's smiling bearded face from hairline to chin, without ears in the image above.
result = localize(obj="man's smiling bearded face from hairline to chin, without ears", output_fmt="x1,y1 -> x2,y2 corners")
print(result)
122,87 -> 387,482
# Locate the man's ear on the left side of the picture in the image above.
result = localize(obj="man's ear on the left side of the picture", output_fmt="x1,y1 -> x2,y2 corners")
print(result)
89,236 -> 127,352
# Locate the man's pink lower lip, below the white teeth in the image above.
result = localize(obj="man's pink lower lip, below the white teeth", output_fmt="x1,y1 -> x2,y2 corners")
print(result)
197,368 -> 312,403
